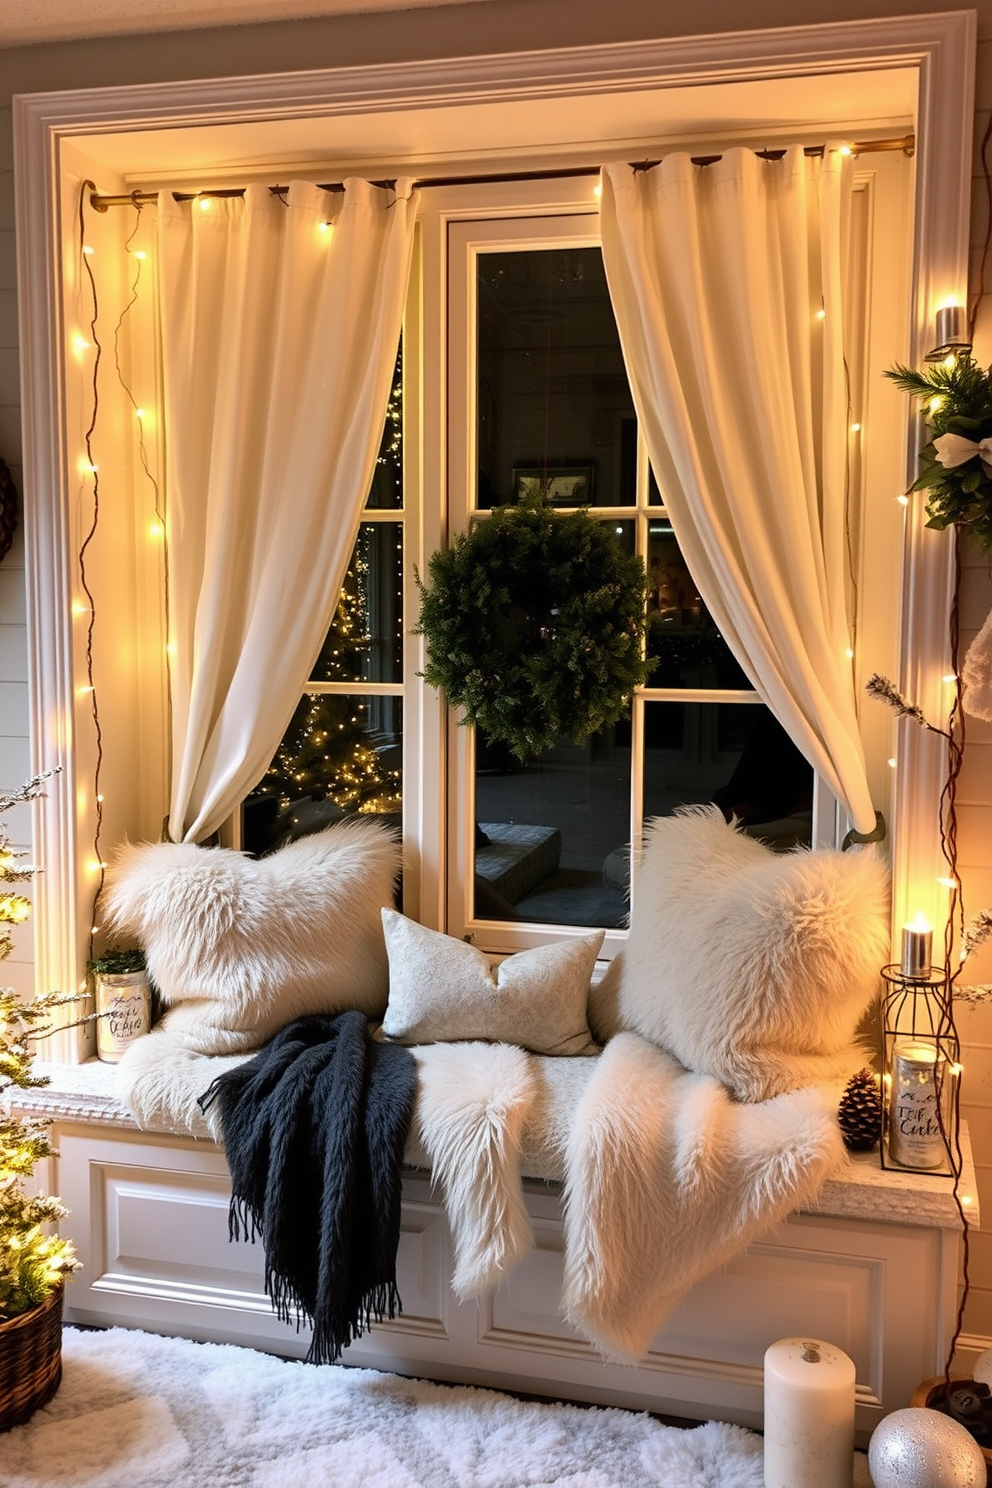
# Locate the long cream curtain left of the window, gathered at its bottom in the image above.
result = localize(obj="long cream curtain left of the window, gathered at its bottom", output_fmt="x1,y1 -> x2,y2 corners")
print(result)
159,180 -> 415,842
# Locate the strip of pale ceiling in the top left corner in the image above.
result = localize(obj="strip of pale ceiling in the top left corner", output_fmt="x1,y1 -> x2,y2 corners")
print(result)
0,0 -> 496,48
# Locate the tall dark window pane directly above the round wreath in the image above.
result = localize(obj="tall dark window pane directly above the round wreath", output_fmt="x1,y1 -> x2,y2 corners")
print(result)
477,248 -> 637,509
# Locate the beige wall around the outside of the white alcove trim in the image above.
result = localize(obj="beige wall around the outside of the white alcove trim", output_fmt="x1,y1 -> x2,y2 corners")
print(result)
0,0 -> 992,1341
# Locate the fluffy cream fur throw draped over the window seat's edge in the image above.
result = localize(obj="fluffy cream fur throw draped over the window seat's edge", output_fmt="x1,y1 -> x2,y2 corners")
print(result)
119,1031 -> 843,1360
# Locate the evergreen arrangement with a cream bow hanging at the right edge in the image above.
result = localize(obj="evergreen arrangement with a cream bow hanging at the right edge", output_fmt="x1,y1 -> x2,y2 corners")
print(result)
885,356 -> 992,552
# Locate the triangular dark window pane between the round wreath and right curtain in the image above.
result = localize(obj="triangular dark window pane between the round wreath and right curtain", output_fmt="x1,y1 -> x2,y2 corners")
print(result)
647,516 -> 751,690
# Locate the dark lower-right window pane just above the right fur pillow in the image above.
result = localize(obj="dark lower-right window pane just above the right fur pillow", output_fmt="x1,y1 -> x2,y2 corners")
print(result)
644,690 -> 814,847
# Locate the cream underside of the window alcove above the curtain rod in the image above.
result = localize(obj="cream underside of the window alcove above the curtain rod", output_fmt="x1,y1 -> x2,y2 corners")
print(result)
71,66 -> 918,192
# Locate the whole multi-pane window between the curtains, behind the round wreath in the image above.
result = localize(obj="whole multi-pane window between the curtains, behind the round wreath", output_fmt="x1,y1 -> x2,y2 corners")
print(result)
242,188 -> 812,949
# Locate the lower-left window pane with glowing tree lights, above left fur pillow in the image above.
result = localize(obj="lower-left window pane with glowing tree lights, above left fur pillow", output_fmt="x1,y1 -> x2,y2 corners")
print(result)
242,693 -> 403,853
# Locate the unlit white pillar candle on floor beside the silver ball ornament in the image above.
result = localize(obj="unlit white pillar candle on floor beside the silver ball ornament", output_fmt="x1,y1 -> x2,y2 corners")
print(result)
764,1338 -> 855,1488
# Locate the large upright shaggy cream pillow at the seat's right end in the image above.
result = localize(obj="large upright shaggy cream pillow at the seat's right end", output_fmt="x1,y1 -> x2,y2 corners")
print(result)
590,806 -> 889,1101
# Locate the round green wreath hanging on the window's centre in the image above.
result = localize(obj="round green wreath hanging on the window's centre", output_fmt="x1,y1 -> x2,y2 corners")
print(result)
416,496 -> 650,760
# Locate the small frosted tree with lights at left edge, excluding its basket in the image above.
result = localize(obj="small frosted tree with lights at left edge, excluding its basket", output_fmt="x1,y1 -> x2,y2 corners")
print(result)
0,771 -> 79,1324
